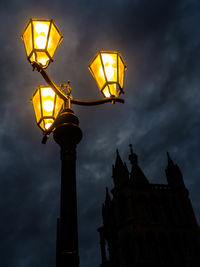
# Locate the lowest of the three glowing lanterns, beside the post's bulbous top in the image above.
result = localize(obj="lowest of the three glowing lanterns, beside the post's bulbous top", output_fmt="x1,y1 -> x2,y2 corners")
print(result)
31,85 -> 64,131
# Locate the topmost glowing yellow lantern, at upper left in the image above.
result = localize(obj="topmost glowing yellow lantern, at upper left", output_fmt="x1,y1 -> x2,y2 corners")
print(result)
21,19 -> 63,68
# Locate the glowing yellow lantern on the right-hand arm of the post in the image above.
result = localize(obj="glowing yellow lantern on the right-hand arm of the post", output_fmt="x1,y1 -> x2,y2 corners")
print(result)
89,51 -> 126,97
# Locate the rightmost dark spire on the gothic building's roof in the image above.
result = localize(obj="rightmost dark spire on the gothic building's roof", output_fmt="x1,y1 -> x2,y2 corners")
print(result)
165,152 -> 185,187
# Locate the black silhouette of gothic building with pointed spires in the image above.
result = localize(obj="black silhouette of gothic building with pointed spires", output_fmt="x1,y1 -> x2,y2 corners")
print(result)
98,145 -> 200,267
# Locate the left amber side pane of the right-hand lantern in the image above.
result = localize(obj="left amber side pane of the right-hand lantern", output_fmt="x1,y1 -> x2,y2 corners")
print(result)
90,55 -> 106,89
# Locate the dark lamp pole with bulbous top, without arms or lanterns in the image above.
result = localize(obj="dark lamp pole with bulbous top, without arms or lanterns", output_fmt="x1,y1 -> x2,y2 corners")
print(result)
53,109 -> 82,267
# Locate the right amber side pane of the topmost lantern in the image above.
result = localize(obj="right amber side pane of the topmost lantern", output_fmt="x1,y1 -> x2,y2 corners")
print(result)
47,23 -> 61,57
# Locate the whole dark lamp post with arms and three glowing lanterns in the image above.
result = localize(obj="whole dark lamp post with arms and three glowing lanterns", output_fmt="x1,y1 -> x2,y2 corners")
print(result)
21,19 -> 126,267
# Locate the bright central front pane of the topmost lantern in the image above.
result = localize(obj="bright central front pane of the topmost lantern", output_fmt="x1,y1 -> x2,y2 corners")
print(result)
33,21 -> 50,49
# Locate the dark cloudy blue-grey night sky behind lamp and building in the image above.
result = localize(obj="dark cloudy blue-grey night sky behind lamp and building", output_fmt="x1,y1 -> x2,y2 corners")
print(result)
0,0 -> 200,267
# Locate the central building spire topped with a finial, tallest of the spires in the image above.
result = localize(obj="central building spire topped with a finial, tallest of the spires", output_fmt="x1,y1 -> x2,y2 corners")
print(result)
129,144 -> 149,185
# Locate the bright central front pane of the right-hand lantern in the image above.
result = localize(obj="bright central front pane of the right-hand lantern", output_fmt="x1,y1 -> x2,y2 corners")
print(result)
101,53 -> 117,82
